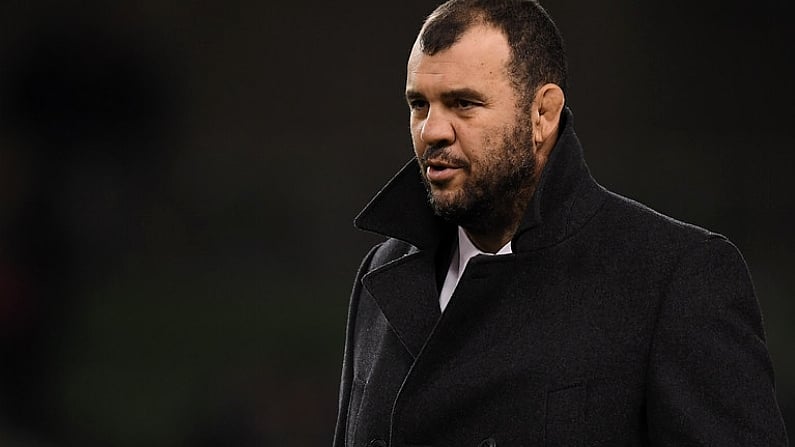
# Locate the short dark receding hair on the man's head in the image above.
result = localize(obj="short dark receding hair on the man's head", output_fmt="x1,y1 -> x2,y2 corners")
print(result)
419,0 -> 568,101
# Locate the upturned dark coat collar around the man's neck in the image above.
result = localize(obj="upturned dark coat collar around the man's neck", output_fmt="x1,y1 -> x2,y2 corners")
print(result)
354,107 -> 605,252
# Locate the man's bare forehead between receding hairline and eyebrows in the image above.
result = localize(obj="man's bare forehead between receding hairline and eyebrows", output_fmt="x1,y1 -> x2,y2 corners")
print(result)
406,25 -> 510,89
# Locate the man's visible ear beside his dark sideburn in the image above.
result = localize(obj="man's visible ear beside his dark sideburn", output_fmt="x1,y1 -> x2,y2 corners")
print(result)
531,84 -> 566,162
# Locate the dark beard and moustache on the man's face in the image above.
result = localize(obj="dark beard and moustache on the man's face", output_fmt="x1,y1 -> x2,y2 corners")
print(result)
420,123 -> 537,233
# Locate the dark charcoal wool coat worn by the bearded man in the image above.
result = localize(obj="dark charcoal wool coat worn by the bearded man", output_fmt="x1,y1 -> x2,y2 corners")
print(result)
334,109 -> 787,447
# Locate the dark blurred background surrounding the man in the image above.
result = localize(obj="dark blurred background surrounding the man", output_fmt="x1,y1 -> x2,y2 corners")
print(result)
0,0 -> 795,447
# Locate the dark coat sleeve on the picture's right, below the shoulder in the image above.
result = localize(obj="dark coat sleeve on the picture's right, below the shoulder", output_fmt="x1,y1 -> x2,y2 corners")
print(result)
646,236 -> 787,447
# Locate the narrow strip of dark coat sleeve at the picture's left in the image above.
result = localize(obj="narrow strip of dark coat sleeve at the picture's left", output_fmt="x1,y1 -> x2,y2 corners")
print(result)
333,246 -> 379,447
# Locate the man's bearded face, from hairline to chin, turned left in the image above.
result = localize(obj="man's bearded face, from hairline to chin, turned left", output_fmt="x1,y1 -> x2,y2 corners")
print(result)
406,22 -> 535,229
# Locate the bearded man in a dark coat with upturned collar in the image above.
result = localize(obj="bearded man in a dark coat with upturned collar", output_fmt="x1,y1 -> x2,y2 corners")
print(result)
334,0 -> 787,447
